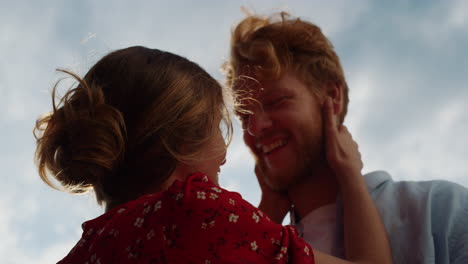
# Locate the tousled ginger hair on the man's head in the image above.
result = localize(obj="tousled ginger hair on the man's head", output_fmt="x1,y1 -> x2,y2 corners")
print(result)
224,12 -> 349,122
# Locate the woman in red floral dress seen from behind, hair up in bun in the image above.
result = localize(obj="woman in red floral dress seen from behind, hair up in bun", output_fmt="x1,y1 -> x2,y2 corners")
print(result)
35,47 -> 389,264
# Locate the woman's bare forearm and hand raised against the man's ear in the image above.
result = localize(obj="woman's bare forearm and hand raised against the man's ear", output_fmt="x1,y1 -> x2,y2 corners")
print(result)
316,100 -> 392,264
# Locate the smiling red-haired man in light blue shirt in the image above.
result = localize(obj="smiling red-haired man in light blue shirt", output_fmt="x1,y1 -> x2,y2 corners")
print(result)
226,13 -> 468,264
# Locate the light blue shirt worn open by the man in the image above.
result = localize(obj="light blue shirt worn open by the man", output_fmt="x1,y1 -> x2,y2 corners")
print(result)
296,171 -> 468,264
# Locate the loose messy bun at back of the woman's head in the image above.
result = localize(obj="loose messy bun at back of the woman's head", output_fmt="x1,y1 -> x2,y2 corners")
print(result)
34,70 -> 126,193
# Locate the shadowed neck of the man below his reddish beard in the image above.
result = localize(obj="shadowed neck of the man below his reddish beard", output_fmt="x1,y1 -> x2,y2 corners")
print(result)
288,167 -> 339,221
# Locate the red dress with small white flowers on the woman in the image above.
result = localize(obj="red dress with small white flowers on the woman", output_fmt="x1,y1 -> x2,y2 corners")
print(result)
59,173 -> 314,264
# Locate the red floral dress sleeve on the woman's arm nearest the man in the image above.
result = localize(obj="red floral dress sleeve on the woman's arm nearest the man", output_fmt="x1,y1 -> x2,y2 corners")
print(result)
164,174 -> 314,264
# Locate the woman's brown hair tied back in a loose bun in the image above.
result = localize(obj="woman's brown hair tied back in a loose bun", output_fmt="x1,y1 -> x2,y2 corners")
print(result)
34,47 -> 232,207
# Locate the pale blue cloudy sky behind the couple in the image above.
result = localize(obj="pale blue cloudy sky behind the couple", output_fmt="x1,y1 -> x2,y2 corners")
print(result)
0,0 -> 468,264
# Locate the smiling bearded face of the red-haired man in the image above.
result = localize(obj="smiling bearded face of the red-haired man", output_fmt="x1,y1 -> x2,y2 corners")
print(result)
235,72 -> 324,190
